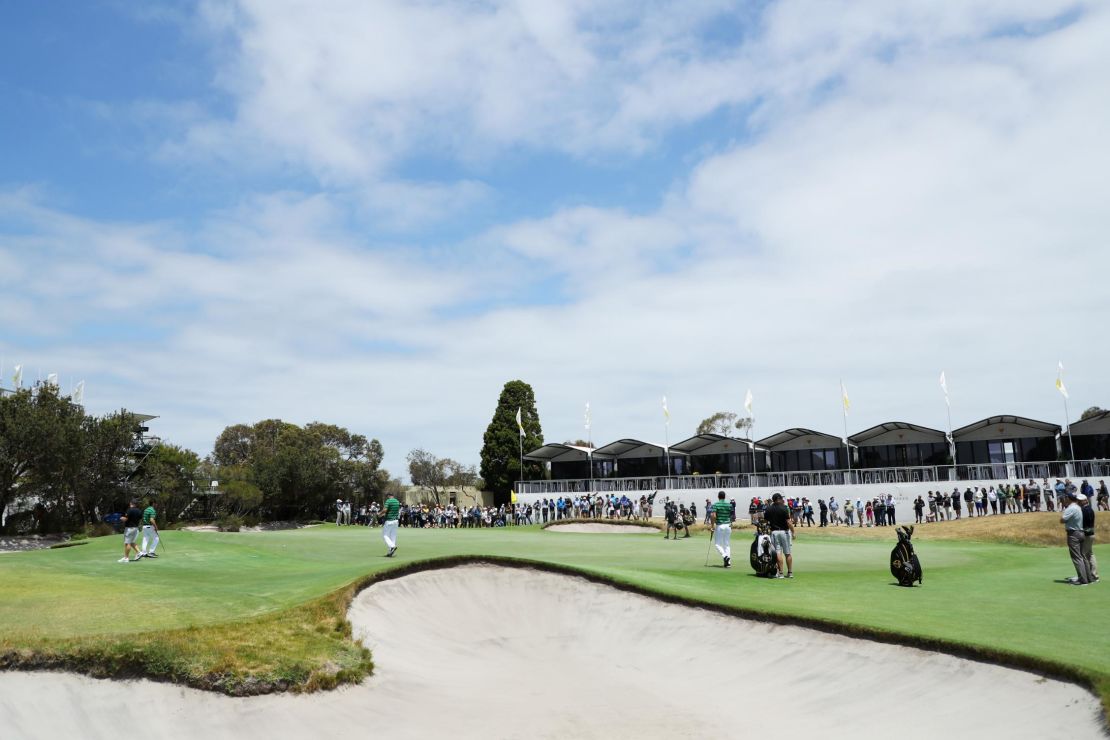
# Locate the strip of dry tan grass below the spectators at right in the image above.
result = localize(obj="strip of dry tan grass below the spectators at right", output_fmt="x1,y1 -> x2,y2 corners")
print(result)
800,511 -> 1110,547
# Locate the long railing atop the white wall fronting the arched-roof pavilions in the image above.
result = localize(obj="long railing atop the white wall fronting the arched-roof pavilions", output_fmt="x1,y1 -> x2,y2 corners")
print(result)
516,459 -> 1110,495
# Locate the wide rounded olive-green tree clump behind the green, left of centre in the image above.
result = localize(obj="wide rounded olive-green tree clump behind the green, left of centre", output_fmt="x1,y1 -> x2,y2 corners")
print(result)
212,419 -> 389,519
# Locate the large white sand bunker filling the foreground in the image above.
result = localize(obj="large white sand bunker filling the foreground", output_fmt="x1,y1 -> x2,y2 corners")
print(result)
0,566 -> 1103,740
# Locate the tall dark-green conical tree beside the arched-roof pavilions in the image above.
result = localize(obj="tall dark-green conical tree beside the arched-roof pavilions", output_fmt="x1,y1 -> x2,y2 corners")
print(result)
482,381 -> 544,505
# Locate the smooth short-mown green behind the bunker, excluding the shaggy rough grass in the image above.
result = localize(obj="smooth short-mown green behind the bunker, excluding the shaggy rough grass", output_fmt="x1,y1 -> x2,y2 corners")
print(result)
0,525 -> 1110,695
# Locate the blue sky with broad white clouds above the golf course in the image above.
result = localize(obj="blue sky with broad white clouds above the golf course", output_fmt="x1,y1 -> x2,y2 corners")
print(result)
0,0 -> 1110,477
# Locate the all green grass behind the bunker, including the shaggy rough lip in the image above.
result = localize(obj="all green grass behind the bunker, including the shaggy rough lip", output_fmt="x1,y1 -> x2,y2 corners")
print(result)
0,526 -> 1110,710
